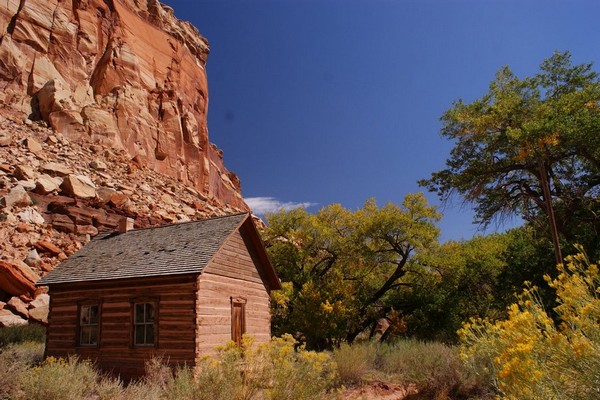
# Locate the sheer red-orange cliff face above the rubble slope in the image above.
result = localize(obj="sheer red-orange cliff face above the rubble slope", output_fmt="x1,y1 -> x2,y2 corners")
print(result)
0,0 -> 248,210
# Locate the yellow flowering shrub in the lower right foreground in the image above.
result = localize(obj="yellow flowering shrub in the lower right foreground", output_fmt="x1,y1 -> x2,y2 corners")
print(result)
459,249 -> 600,400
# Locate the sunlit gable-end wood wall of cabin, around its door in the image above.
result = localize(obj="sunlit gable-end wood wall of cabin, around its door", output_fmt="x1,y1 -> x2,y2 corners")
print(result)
196,231 -> 271,356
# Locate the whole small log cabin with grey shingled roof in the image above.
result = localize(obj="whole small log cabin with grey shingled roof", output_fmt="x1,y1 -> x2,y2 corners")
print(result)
37,214 -> 281,379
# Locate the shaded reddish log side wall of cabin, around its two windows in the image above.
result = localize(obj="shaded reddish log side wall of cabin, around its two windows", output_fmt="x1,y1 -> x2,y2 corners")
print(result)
46,275 -> 197,378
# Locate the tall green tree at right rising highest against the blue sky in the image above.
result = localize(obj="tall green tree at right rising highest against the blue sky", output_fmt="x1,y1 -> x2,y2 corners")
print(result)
420,52 -> 600,262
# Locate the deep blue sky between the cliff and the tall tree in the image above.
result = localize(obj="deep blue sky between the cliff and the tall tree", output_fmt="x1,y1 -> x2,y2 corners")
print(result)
164,0 -> 600,240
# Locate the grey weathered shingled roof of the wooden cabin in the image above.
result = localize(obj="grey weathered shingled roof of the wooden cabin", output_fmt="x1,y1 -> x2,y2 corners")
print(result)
37,214 -> 278,286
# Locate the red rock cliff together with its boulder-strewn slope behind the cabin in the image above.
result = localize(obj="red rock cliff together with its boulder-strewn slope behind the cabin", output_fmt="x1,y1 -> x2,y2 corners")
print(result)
0,0 -> 248,327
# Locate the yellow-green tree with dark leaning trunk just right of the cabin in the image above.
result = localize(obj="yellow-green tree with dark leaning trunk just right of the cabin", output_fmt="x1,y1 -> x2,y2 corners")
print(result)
263,194 -> 440,349
